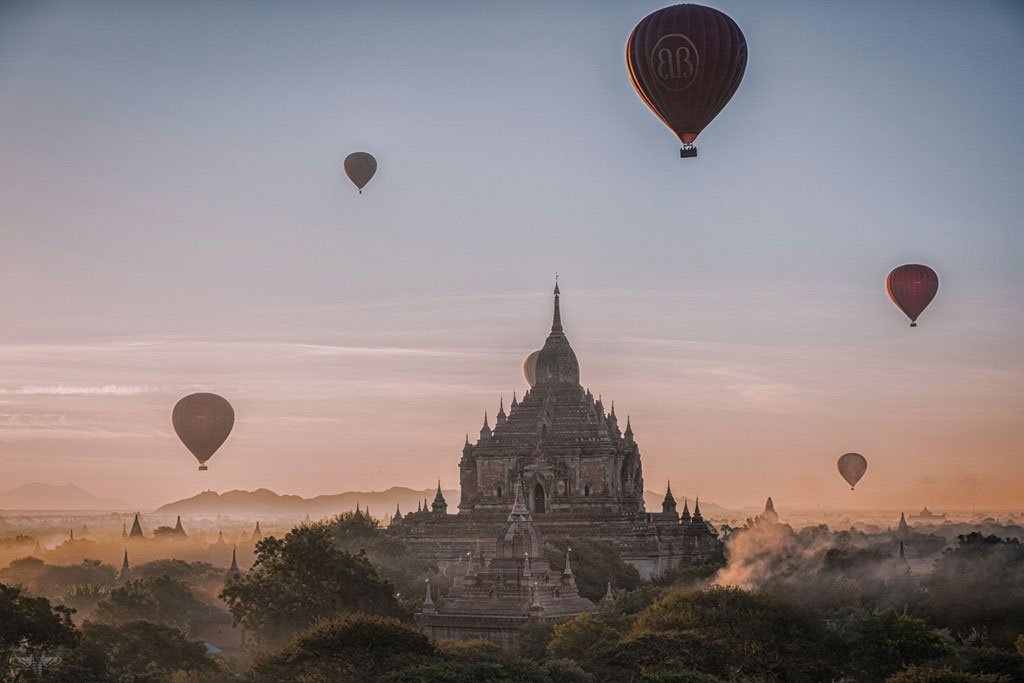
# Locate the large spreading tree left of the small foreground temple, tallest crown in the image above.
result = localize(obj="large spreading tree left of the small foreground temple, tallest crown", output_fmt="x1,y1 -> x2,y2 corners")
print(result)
221,524 -> 401,642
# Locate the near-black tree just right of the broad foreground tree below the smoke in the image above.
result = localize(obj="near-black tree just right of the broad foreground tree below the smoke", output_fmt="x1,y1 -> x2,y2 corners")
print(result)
846,611 -> 951,680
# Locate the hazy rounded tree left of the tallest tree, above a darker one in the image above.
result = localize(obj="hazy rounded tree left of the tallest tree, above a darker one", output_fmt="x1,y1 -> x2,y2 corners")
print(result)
94,574 -> 212,631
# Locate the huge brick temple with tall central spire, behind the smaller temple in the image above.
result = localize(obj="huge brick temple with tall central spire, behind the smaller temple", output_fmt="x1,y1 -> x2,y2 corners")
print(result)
391,284 -> 719,577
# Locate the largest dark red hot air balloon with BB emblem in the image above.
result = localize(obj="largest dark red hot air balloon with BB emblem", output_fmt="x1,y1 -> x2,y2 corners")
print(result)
626,5 -> 746,157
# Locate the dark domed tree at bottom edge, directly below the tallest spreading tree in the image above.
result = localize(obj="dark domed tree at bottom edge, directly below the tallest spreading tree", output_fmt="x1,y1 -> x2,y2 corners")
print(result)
246,613 -> 438,683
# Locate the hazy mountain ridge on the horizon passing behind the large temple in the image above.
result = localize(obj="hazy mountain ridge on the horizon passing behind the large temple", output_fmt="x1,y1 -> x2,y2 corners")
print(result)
156,486 -> 728,518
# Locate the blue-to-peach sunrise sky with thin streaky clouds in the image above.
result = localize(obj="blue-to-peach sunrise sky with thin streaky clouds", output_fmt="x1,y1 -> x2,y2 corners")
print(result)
0,0 -> 1024,509
